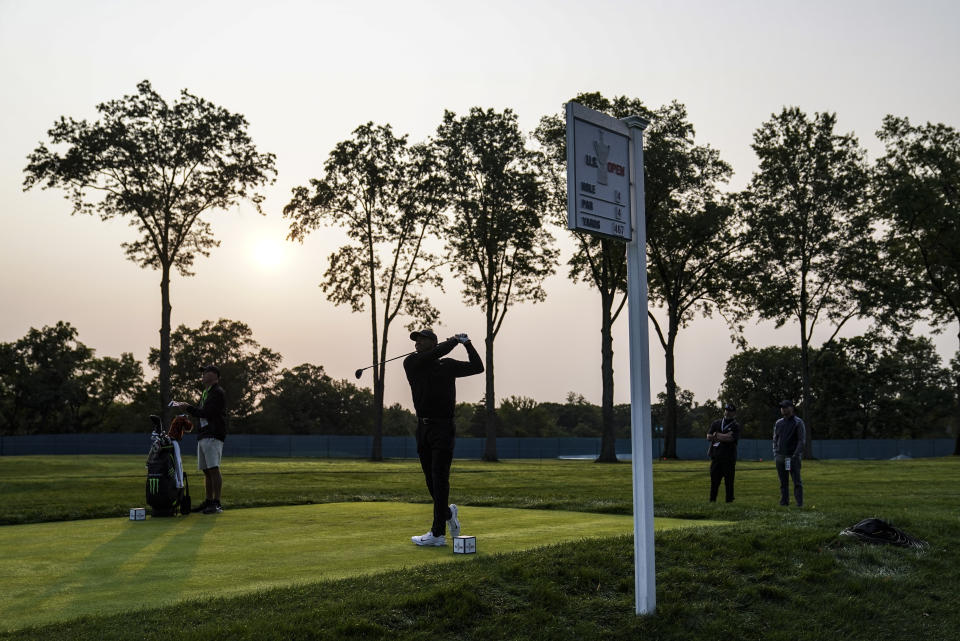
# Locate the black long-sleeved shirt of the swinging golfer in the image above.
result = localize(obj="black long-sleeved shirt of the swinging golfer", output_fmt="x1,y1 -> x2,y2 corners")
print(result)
403,338 -> 483,419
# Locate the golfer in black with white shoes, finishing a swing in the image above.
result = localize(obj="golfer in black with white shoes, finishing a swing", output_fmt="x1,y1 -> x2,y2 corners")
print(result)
403,329 -> 483,546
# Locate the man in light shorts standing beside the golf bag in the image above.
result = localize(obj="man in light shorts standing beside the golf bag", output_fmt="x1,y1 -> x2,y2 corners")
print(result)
171,365 -> 227,514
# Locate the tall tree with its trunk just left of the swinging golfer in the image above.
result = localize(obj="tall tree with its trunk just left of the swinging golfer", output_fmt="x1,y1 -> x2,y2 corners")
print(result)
283,122 -> 444,460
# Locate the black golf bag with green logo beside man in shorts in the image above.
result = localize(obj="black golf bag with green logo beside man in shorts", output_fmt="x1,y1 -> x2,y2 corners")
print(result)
146,416 -> 190,516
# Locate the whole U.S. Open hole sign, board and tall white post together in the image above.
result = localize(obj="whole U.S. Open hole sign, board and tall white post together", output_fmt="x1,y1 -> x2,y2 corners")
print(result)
567,102 -> 657,614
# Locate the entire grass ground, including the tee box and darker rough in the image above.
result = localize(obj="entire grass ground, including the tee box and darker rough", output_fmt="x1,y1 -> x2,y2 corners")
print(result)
0,456 -> 960,641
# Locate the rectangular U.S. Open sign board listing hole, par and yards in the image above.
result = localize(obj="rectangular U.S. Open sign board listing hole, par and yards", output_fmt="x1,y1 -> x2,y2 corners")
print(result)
567,102 -> 633,240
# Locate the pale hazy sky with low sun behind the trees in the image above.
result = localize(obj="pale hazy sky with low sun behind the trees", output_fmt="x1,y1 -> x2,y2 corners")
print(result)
0,0 -> 960,406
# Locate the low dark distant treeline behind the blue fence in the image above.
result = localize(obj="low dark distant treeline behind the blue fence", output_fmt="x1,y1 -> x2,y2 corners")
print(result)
0,319 -> 955,439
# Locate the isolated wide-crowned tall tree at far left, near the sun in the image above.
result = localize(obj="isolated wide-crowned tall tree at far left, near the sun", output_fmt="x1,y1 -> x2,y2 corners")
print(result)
24,80 -> 276,420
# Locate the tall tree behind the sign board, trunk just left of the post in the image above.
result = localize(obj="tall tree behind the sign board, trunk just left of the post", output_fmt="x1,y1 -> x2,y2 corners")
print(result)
534,92 -> 651,463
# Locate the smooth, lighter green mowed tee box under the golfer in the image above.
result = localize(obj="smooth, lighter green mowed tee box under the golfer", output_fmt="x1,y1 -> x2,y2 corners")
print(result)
0,503 -> 722,630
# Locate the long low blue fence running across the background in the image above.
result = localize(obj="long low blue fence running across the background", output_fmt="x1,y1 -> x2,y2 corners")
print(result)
0,434 -> 954,460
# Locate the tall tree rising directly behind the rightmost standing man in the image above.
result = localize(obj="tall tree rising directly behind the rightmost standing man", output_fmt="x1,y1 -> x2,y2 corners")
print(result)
740,107 -> 877,455
